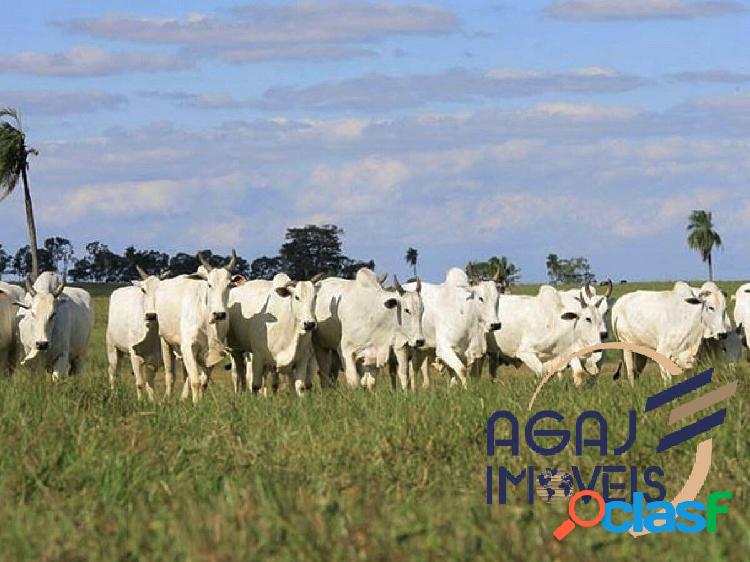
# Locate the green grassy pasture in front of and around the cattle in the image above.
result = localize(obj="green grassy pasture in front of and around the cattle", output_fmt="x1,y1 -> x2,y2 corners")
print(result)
0,283 -> 750,562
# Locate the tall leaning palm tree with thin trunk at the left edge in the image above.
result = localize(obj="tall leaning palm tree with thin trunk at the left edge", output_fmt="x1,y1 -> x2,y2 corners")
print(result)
0,108 -> 39,279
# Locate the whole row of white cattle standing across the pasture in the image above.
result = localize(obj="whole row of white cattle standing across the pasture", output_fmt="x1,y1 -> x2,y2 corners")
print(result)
0,252 -> 750,401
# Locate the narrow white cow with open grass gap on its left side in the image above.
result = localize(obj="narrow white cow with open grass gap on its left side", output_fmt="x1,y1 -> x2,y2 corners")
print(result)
106,266 -> 169,400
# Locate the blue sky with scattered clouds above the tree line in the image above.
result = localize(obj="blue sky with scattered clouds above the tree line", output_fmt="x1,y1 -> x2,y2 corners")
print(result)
0,0 -> 750,281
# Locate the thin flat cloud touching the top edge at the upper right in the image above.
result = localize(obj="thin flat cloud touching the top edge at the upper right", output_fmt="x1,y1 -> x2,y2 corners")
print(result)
546,0 -> 746,21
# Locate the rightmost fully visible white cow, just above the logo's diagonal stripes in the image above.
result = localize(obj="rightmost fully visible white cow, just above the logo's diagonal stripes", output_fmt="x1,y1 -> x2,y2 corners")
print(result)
612,281 -> 732,384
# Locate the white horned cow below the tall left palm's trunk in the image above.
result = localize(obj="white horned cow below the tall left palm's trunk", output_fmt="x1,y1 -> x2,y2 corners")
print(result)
18,271 -> 94,381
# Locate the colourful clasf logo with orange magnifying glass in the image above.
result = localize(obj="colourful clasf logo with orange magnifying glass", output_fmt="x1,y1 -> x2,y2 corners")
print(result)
553,490 -> 732,541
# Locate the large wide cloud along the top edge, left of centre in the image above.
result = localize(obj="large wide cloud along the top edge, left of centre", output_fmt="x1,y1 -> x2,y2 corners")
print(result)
56,0 -> 459,63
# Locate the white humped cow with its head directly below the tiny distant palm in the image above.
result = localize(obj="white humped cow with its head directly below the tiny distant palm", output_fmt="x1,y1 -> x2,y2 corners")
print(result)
313,268 -> 424,389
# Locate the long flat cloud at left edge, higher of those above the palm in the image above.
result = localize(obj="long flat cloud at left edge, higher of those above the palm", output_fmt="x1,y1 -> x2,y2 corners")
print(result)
0,47 -> 189,77
